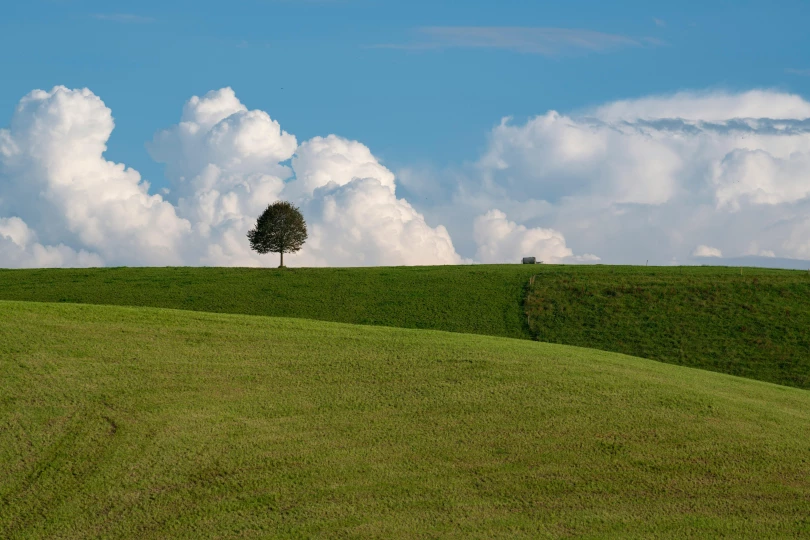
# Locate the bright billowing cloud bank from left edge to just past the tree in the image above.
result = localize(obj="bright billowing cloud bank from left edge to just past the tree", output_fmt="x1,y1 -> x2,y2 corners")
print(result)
0,87 -> 480,266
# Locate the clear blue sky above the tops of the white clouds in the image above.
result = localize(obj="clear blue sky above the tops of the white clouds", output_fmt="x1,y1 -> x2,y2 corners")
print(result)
6,0 -> 810,190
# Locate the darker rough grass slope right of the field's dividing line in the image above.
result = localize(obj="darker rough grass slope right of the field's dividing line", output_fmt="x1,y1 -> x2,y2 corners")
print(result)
526,266 -> 810,388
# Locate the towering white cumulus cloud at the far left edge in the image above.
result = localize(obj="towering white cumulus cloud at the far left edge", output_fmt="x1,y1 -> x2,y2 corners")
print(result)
0,87 -> 190,264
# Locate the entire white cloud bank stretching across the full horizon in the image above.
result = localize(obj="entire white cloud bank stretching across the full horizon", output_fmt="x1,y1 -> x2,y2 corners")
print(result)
0,87 -> 810,266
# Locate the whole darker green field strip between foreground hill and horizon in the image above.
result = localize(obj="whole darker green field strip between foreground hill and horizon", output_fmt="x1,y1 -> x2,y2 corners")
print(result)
0,265 -> 810,389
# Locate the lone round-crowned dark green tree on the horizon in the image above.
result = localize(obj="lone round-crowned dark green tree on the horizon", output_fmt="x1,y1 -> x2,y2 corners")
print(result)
248,201 -> 307,268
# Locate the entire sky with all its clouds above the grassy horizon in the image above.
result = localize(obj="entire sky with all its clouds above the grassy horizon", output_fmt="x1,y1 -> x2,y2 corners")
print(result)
0,0 -> 810,266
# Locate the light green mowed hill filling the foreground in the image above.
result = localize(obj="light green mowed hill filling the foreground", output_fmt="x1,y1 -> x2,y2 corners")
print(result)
0,302 -> 810,538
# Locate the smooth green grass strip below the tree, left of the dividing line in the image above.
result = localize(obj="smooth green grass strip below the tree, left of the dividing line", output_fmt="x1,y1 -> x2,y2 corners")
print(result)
0,265 -> 533,338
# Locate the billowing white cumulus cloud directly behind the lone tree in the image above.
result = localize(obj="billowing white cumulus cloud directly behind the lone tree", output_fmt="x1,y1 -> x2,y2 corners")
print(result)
149,88 -> 461,266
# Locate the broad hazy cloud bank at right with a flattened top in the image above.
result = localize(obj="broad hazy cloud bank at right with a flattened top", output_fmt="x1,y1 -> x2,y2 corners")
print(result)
450,91 -> 810,264
